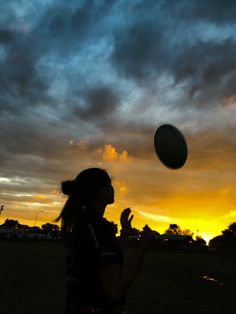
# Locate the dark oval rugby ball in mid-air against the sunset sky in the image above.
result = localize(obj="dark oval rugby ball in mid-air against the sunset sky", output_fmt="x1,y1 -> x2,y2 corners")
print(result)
154,124 -> 188,169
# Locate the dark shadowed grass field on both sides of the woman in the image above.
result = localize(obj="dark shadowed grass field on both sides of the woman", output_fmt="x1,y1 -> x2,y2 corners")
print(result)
0,241 -> 236,314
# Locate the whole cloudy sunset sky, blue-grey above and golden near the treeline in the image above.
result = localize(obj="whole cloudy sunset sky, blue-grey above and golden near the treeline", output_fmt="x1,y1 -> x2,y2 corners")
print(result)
0,0 -> 236,242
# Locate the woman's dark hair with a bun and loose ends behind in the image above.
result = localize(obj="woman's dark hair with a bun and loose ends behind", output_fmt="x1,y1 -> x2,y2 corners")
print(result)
55,168 -> 111,245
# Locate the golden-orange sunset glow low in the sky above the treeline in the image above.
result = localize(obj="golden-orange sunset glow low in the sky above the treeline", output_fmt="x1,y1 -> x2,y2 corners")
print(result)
1,133 -> 236,241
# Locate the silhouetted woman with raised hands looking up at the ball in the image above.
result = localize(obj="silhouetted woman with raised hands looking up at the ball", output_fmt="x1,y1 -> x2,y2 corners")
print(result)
56,168 -> 154,314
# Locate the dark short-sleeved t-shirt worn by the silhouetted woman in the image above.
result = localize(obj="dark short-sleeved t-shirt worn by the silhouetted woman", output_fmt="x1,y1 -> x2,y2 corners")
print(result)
66,209 -> 125,314
